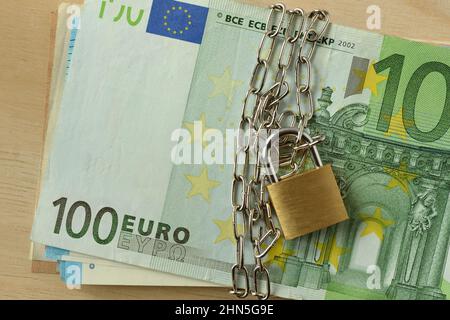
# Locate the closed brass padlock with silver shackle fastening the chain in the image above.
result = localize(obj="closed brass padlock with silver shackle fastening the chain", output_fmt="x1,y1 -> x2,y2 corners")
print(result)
266,128 -> 348,240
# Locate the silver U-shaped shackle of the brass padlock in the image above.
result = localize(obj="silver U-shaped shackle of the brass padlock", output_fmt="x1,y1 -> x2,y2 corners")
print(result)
263,128 -> 323,183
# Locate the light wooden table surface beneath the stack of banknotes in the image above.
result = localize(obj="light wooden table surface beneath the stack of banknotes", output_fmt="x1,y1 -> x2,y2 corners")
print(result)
0,0 -> 450,299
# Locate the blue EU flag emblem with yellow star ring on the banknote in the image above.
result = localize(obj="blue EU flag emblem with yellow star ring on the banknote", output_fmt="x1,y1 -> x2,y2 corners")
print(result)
147,0 -> 208,44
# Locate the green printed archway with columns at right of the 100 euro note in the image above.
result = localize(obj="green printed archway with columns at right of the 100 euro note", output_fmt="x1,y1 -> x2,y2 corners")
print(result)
271,88 -> 450,299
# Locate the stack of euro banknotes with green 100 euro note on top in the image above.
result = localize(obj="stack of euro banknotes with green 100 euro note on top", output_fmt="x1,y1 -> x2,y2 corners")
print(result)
31,0 -> 450,299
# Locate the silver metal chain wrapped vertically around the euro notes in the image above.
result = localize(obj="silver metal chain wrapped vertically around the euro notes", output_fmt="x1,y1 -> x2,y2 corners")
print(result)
231,3 -> 328,300
